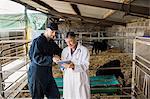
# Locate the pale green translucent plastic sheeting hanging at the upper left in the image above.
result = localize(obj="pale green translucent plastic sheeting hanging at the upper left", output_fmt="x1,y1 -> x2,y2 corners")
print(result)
0,13 -> 47,30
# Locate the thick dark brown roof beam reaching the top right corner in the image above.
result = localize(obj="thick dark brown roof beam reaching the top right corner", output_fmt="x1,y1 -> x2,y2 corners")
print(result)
58,0 -> 150,16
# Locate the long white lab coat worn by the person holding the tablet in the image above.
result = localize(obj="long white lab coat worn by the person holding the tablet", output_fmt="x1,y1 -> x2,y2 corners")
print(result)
62,43 -> 90,99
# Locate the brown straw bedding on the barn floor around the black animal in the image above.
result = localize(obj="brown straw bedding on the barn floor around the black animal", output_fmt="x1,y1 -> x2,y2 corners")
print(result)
17,49 -> 132,99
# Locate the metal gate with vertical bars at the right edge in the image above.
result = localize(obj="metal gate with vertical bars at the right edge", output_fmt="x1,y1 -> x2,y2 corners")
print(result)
132,37 -> 150,99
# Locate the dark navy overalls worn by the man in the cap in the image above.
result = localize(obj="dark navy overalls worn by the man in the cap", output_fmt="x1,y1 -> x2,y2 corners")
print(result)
28,34 -> 61,96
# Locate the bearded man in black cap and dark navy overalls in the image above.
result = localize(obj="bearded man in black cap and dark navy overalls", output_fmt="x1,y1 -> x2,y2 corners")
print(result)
28,23 -> 61,99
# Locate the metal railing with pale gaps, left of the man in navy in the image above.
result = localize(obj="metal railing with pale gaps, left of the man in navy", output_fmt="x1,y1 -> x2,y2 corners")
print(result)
0,40 -> 30,98
